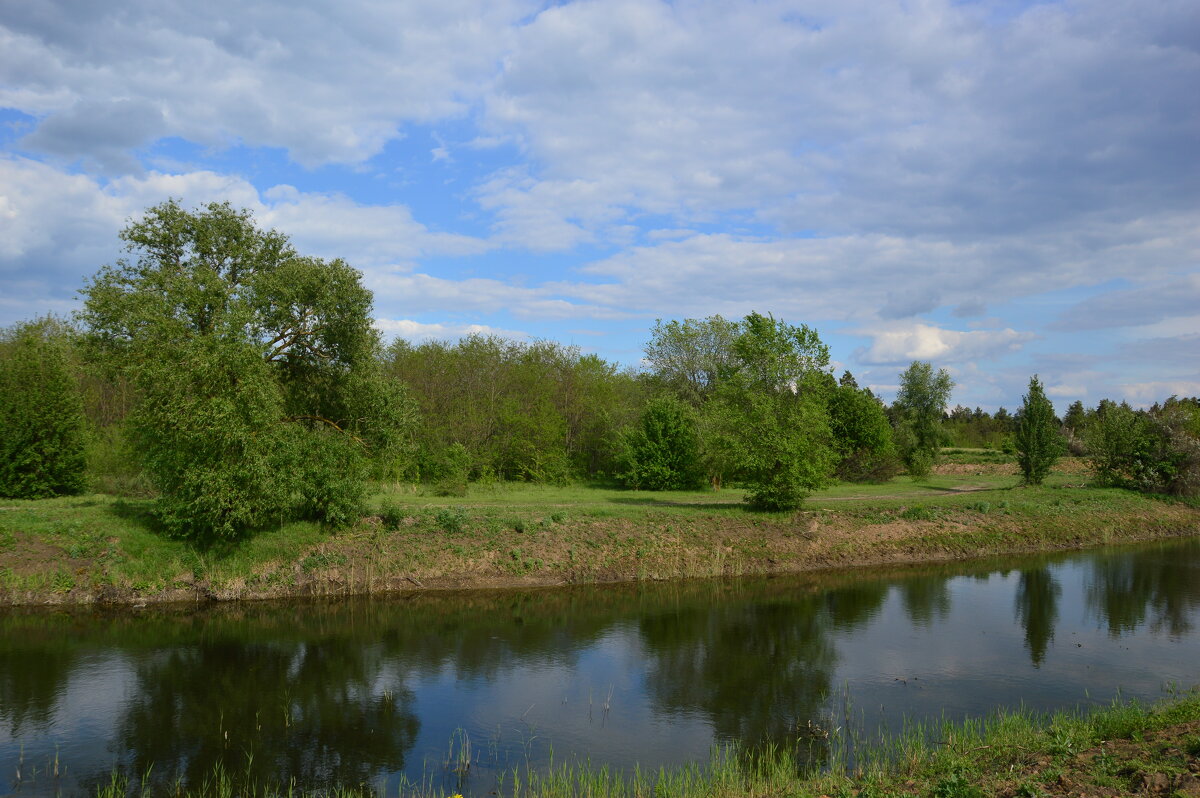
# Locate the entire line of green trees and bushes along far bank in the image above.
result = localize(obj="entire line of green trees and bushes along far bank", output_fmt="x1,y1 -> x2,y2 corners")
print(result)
0,202 -> 1200,539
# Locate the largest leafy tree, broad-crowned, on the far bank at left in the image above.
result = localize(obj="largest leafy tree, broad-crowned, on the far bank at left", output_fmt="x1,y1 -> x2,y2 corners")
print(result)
80,200 -> 413,538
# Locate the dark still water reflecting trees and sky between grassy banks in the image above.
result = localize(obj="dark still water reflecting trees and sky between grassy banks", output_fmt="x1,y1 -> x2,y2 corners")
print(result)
0,541 -> 1200,794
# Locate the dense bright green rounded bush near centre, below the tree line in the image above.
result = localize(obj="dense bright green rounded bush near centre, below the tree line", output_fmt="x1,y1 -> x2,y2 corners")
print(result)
617,397 -> 701,491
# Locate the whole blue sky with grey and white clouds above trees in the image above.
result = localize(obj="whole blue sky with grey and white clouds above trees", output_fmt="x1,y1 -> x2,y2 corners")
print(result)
0,0 -> 1200,412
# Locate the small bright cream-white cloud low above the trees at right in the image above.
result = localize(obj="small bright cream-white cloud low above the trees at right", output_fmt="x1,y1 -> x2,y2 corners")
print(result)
854,323 -> 1034,364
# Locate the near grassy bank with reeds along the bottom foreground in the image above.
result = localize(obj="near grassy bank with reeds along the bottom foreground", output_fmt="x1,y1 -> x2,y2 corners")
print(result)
87,692 -> 1200,798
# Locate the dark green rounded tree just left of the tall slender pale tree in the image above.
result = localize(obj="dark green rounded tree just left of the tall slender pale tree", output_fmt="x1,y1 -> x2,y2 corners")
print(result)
829,384 -> 896,482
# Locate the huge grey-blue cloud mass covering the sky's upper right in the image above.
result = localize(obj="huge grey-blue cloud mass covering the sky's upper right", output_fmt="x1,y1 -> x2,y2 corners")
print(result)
475,0 -> 1200,249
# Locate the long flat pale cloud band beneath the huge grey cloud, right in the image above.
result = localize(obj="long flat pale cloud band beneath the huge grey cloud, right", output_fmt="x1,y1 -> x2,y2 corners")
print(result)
563,226 -> 1200,320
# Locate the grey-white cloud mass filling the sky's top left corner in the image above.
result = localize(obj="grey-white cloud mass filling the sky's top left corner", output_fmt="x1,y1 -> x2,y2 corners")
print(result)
0,0 -> 536,164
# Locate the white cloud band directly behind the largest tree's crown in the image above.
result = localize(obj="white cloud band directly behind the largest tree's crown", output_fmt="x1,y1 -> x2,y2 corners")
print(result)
0,156 -> 488,318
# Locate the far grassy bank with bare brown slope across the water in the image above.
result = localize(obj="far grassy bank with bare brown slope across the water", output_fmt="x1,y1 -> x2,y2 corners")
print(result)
0,456 -> 1200,605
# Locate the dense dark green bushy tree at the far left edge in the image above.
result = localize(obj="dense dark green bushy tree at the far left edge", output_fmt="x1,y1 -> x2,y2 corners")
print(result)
0,318 -> 86,499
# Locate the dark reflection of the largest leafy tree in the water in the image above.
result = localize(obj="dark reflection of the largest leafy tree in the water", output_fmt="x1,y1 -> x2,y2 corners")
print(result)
105,637 -> 419,788
